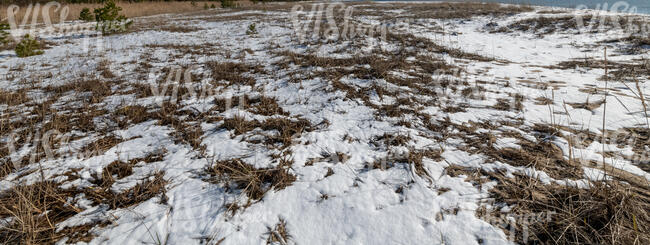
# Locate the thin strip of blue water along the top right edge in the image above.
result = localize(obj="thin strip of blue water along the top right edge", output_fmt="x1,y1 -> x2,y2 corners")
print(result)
374,0 -> 650,14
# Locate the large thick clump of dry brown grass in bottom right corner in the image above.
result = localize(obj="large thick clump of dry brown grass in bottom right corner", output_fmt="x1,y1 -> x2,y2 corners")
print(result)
445,166 -> 650,244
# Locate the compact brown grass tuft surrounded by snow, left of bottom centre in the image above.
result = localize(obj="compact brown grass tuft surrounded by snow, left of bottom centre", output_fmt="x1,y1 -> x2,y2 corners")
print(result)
205,159 -> 296,201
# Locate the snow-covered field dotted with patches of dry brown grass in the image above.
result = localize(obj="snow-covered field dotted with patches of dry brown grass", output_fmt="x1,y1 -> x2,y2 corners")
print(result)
0,0 -> 650,244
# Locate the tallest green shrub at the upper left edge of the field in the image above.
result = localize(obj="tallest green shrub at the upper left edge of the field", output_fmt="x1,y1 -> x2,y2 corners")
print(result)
93,0 -> 133,35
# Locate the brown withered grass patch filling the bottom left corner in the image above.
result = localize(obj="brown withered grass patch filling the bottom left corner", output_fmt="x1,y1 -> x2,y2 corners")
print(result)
0,172 -> 167,244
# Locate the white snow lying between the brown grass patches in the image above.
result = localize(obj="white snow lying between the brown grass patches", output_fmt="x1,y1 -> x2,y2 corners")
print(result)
0,2 -> 650,244
